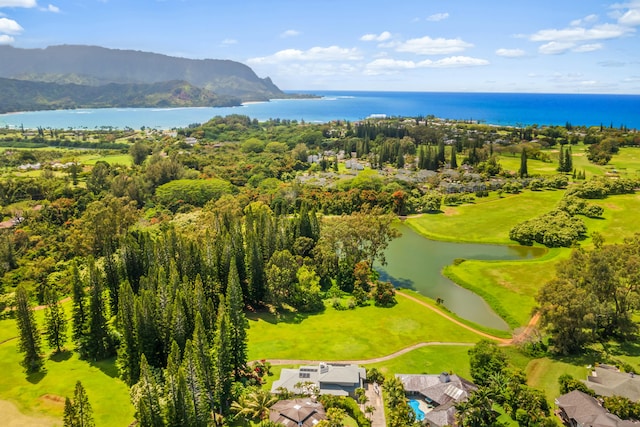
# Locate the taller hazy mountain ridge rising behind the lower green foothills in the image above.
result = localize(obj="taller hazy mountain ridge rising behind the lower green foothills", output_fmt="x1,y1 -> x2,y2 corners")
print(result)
0,45 -> 300,111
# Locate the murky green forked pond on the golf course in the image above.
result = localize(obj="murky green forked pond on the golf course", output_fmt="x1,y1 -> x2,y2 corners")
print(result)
376,224 -> 545,330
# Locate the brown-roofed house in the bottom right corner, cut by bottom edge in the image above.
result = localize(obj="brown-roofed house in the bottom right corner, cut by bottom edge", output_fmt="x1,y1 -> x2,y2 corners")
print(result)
555,390 -> 640,427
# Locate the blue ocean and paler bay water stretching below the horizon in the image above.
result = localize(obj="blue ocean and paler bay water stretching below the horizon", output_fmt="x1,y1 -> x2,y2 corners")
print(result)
0,91 -> 640,129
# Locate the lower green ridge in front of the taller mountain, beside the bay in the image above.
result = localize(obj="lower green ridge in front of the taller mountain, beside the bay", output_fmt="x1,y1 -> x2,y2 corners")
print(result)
0,78 -> 241,113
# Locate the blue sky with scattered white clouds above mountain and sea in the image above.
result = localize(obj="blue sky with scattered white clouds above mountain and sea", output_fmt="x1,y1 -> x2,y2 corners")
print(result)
0,0 -> 640,94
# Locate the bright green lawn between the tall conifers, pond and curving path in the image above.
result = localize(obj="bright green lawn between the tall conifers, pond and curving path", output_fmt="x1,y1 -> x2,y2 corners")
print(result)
248,297 -> 488,362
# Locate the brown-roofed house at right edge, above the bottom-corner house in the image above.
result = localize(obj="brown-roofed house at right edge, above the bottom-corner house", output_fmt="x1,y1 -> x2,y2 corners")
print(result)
583,365 -> 640,402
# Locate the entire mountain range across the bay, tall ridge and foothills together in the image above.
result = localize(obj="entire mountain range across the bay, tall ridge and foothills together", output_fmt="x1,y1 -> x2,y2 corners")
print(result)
0,45 -> 291,112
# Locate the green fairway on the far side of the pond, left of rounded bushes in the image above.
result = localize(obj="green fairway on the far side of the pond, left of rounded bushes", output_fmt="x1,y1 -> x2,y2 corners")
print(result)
406,190 -> 564,244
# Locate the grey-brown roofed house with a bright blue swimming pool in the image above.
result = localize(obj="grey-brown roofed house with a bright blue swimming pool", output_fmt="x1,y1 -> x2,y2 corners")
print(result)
396,372 -> 478,427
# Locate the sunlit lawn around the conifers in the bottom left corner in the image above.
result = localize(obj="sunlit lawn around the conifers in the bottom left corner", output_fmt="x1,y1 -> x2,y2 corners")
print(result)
0,303 -> 134,427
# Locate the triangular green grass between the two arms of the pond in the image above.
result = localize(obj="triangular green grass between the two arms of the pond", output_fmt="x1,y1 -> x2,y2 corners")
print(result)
445,249 -> 570,328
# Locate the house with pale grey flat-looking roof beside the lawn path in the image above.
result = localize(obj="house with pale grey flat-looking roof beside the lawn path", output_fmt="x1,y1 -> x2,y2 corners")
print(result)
271,363 -> 367,397
